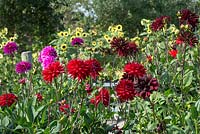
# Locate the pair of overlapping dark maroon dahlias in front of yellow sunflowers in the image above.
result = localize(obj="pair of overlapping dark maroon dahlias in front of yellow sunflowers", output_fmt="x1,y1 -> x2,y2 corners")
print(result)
110,37 -> 138,57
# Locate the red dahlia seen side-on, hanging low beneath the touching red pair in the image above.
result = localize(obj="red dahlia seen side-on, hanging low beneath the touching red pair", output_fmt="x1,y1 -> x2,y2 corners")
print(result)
90,88 -> 110,107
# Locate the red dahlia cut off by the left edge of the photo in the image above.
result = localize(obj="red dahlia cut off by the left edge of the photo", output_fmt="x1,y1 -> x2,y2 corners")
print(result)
0,93 -> 17,107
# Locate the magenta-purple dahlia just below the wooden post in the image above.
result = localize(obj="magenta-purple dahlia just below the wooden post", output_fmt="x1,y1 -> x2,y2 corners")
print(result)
15,61 -> 32,74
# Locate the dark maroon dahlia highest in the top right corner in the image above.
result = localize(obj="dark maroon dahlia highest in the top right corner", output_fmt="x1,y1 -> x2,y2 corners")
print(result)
179,9 -> 199,28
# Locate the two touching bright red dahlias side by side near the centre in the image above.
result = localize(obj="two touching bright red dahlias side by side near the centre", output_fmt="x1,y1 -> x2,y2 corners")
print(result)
67,59 -> 103,81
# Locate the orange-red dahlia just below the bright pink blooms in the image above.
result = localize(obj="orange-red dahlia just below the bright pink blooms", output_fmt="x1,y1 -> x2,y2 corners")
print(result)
42,61 -> 64,83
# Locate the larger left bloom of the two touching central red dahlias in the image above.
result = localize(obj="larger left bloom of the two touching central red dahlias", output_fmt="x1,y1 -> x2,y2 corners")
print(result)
66,59 -> 90,81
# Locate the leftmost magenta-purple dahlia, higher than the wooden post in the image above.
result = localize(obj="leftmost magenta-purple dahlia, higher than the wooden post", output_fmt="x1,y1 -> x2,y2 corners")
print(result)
3,42 -> 18,55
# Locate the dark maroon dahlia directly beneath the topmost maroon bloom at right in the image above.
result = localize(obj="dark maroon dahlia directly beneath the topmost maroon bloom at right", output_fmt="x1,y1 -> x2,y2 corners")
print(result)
176,31 -> 198,47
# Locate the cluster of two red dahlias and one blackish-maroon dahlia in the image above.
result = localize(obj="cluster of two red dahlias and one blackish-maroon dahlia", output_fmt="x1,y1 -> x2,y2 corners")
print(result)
115,62 -> 159,102
